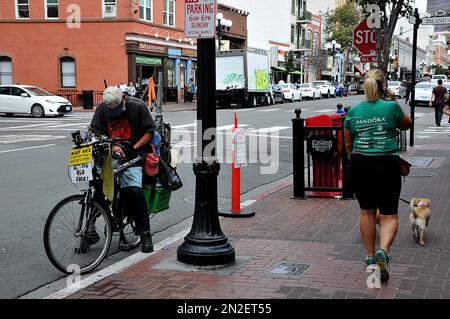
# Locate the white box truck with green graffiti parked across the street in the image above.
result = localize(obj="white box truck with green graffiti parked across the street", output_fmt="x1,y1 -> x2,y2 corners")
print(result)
216,49 -> 270,107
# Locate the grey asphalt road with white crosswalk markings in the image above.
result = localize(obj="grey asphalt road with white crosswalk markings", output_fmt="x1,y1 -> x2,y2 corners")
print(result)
0,95 -> 438,298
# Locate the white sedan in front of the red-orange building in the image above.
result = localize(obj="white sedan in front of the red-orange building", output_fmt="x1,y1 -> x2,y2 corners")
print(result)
0,85 -> 73,117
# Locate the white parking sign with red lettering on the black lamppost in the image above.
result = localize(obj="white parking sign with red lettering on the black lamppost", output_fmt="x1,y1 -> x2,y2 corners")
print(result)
184,0 -> 217,38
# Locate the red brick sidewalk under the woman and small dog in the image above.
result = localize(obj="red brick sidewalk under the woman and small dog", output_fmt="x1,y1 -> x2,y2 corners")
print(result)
60,139 -> 450,299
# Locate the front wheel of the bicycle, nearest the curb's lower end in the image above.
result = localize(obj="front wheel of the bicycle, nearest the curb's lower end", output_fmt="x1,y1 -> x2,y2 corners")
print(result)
44,195 -> 112,274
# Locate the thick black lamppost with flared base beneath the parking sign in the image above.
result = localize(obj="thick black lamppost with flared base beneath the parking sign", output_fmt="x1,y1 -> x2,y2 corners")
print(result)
177,11 -> 235,266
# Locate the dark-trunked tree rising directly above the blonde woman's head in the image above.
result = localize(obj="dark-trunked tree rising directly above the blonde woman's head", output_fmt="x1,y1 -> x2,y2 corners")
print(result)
355,0 -> 415,78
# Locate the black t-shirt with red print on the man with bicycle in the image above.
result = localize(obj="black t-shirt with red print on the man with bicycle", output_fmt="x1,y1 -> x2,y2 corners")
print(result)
91,97 -> 156,151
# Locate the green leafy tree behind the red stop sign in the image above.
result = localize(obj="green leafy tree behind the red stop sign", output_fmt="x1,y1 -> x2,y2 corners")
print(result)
325,2 -> 362,84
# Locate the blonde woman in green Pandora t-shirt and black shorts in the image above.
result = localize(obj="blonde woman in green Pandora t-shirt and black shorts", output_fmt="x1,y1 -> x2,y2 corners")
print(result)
344,69 -> 412,282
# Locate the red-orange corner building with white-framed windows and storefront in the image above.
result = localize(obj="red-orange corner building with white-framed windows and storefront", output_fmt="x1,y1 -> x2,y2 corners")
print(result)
0,0 -> 197,101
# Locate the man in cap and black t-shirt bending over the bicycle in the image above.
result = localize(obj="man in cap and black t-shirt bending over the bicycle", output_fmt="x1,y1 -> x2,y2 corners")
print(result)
89,87 -> 156,253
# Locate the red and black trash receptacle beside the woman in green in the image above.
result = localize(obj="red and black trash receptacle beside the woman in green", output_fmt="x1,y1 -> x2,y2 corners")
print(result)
305,114 -> 344,192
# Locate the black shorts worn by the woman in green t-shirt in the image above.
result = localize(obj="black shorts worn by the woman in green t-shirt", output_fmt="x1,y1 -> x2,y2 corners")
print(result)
349,154 -> 402,215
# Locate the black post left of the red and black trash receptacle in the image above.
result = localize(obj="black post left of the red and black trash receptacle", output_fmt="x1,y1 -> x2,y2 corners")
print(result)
292,109 -> 306,199
